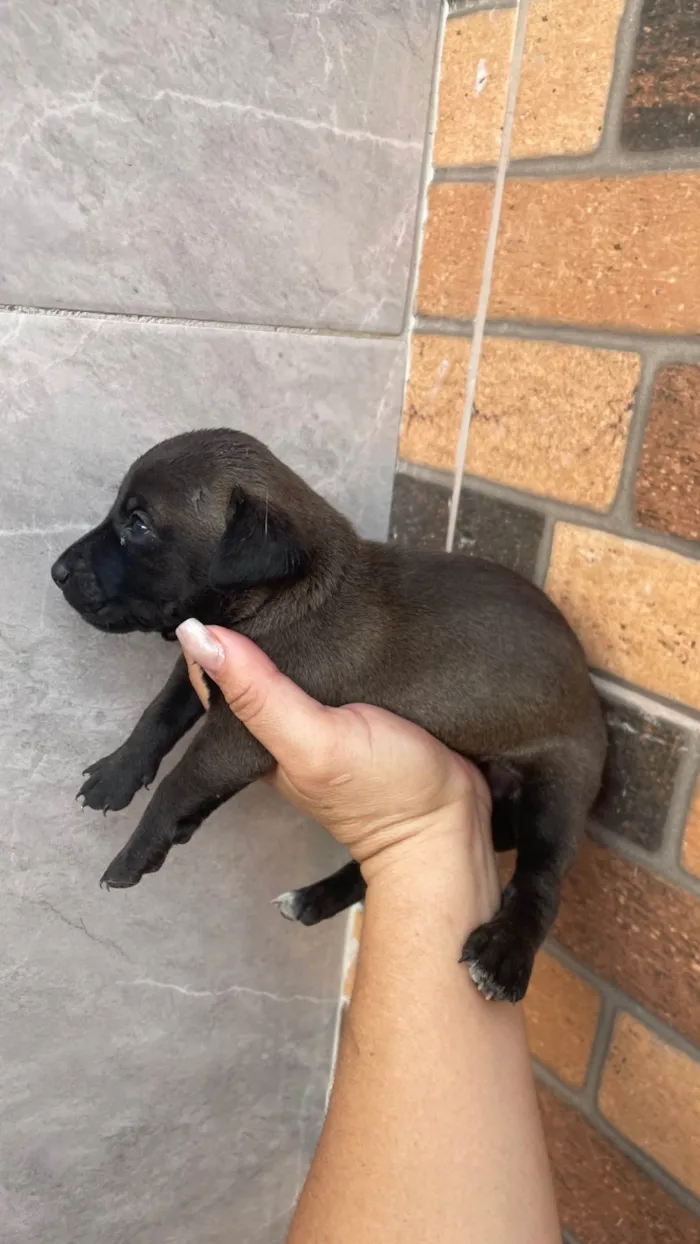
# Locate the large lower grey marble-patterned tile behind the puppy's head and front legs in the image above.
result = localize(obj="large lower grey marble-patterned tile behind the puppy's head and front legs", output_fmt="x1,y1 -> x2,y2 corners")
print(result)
0,306 -> 404,1244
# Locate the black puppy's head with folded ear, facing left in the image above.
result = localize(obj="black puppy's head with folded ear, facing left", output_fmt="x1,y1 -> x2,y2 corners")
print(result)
51,429 -> 333,638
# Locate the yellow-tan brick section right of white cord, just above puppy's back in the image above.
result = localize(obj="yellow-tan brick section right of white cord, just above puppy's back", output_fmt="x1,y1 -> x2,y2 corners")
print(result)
466,337 -> 639,510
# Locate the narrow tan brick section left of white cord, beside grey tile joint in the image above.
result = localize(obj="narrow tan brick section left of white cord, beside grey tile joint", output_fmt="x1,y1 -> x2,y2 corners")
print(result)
399,335 -> 469,470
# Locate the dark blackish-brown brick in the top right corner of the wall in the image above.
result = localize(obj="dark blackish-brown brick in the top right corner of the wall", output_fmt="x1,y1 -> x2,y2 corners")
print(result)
622,0 -> 700,151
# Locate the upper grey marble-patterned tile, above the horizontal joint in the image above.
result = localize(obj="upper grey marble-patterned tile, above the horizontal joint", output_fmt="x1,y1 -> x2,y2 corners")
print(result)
0,0 -> 439,332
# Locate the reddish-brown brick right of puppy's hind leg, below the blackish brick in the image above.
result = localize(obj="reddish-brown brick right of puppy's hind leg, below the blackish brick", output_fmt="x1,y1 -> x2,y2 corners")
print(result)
555,840 -> 700,1044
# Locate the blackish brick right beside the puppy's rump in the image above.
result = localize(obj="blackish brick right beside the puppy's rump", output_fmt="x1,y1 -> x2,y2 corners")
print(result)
593,700 -> 686,851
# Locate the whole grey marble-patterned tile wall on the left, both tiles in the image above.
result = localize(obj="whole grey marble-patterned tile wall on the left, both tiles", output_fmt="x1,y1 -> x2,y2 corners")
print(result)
0,0 -> 439,1244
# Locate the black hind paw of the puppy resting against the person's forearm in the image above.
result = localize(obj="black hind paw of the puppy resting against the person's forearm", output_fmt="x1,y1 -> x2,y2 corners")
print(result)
460,913 -> 535,1003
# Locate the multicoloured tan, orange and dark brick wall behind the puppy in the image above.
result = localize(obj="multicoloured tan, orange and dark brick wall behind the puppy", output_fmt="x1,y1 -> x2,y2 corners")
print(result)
392,0 -> 700,1244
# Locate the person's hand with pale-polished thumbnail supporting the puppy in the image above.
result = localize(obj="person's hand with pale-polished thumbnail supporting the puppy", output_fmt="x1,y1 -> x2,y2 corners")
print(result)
178,618 -> 500,914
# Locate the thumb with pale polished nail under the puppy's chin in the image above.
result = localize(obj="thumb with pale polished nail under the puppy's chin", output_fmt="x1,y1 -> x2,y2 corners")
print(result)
177,618 -> 329,771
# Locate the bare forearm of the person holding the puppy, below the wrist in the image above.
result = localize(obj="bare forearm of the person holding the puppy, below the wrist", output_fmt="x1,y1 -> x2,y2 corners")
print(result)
288,850 -> 561,1244
